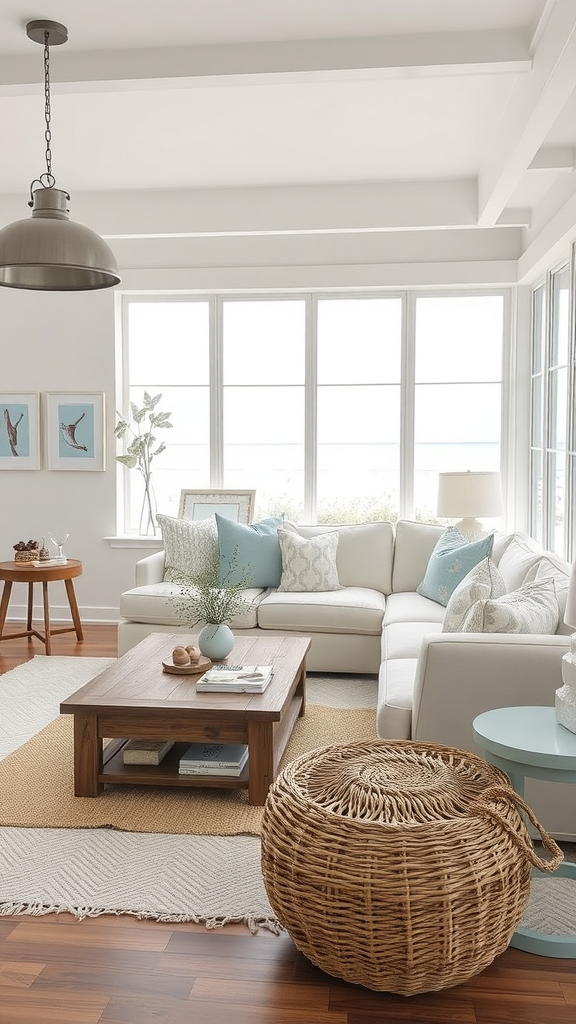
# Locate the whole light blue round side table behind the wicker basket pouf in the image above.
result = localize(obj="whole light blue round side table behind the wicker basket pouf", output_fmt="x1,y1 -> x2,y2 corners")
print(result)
472,708 -> 576,957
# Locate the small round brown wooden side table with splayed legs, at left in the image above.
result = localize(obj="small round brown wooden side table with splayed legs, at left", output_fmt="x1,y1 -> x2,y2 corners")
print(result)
0,558 -> 84,654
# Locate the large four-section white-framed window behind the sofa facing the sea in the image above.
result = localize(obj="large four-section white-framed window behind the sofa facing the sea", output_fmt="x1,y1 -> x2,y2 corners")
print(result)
119,293 -> 505,532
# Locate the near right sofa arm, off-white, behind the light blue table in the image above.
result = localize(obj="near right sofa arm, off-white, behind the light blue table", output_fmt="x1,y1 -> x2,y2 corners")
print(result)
412,633 -> 570,753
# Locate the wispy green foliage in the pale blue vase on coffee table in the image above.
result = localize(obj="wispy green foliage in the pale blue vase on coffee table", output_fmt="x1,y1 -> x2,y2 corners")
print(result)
168,553 -> 253,626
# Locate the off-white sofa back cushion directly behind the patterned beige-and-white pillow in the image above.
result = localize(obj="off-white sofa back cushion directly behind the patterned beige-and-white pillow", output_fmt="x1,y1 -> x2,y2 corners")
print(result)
284,520 -> 394,594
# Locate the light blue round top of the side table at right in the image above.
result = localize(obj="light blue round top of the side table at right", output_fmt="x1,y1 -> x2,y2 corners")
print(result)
472,707 -> 576,771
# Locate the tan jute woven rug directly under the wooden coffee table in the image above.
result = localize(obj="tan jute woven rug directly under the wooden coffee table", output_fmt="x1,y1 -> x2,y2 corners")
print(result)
0,705 -> 376,836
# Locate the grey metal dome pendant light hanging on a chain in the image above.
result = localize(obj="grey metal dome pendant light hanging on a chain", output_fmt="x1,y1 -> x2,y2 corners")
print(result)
0,20 -> 120,292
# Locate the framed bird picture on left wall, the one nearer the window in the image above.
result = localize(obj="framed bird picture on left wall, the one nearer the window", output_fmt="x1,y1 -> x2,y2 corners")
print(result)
45,391 -> 106,472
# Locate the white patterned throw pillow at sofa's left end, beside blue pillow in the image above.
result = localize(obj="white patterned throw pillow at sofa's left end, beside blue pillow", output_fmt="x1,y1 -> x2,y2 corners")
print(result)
156,515 -> 218,583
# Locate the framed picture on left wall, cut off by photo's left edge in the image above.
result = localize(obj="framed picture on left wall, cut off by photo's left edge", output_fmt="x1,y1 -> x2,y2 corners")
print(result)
0,391 -> 40,469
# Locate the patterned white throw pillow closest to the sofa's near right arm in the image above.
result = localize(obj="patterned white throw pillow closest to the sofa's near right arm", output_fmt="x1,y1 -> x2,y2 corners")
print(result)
461,579 -> 559,634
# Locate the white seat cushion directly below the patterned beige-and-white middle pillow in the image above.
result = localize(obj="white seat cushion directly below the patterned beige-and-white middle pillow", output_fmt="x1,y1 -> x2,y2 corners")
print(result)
254,587 -> 385,636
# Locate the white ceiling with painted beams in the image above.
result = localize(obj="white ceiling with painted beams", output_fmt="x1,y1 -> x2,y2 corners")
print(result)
0,0 -> 576,282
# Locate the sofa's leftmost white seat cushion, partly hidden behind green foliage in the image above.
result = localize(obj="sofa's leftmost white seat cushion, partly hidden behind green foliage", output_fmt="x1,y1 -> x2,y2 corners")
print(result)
120,582 -> 266,630
